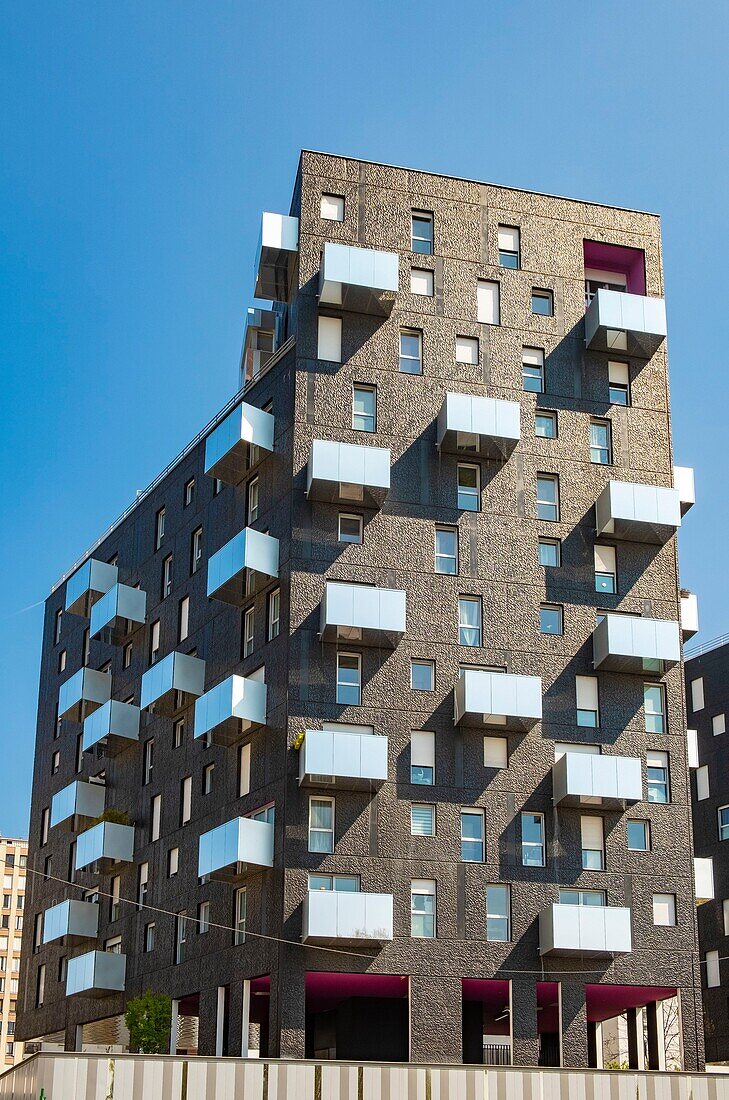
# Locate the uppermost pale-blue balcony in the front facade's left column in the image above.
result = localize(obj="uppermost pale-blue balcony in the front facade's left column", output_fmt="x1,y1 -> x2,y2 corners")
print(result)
319,241 -> 399,317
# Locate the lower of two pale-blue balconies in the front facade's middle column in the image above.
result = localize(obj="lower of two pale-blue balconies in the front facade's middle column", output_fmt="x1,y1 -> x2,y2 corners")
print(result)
453,669 -> 542,733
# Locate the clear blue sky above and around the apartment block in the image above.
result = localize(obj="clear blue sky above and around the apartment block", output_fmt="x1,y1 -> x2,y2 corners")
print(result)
0,0 -> 729,833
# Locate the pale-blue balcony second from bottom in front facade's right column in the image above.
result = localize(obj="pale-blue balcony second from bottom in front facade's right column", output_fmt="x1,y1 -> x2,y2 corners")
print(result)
552,752 -> 643,807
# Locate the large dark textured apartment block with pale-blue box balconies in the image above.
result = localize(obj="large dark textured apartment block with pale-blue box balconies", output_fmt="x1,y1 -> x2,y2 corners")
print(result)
22,152 -> 704,1068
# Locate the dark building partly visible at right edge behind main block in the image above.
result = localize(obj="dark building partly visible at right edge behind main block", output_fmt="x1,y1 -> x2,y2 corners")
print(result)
685,636 -> 729,1062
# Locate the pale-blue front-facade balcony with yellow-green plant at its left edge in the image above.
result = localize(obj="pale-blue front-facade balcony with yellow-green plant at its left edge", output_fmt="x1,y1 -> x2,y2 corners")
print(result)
299,729 -> 387,791
